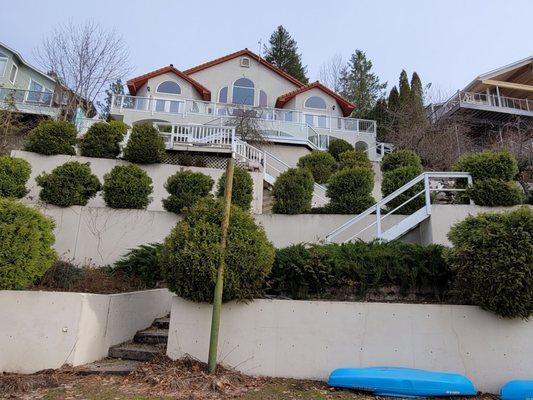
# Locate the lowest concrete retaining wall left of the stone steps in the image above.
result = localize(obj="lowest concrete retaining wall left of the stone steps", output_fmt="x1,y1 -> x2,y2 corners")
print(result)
0,289 -> 171,373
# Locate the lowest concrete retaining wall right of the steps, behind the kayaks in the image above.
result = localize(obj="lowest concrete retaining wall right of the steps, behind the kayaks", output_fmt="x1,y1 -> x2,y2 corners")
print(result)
167,297 -> 533,393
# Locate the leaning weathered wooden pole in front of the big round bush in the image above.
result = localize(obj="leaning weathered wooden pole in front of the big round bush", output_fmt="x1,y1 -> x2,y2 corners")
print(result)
207,153 -> 235,374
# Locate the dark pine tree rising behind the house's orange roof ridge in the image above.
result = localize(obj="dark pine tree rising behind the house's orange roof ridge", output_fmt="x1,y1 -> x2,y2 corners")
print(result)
264,25 -> 309,83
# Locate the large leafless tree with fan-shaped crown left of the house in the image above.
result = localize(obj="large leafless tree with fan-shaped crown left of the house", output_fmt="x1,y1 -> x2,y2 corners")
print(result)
37,22 -> 131,118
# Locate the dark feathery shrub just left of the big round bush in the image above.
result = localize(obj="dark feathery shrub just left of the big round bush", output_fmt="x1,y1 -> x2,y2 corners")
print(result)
114,243 -> 163,288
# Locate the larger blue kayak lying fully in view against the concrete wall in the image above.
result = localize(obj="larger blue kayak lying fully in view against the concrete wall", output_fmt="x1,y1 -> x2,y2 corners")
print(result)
328,367 -> 477,397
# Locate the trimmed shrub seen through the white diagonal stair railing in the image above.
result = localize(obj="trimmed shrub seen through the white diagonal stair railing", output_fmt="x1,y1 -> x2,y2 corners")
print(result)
381,165 -> 425,214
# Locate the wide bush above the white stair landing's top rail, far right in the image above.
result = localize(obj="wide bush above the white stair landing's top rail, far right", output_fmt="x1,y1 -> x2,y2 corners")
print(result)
453,150 -> 518,182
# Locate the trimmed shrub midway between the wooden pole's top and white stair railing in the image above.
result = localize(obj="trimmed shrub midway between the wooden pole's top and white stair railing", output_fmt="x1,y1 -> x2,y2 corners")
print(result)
326,167 -> 375,214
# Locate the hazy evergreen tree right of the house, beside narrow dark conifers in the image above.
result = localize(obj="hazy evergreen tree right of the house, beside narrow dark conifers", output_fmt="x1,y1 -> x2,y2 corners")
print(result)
340,50 -> 387,118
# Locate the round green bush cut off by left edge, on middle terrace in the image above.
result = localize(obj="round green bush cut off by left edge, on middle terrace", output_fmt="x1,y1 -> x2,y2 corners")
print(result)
0,156 -> 31,198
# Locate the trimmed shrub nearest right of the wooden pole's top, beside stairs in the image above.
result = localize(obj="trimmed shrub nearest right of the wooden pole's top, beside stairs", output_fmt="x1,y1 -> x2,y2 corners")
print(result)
272,168 -> 314,214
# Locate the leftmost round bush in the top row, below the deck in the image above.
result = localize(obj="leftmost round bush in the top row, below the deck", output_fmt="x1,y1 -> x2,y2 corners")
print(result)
24,121 -> 78,156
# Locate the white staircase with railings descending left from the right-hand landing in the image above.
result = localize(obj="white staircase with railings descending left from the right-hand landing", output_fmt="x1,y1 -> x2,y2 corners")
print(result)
326,172 -> 472,243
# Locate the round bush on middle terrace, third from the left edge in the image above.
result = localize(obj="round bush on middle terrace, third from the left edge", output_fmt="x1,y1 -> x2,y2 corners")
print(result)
102,164 -> 153,208
